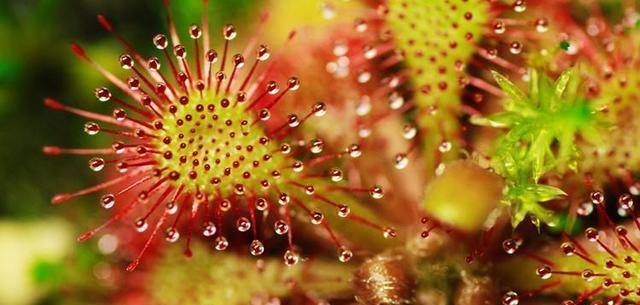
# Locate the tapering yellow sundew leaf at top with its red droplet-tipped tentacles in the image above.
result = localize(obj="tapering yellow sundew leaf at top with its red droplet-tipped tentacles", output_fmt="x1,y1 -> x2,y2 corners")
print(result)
326,0 -> 549,180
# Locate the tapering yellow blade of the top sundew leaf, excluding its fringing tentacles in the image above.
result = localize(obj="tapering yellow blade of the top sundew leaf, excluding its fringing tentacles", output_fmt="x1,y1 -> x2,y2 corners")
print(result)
385,0 -> 490,173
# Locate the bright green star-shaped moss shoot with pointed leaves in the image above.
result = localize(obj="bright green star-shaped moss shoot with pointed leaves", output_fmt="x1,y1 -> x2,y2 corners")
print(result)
472,69 -> 599,227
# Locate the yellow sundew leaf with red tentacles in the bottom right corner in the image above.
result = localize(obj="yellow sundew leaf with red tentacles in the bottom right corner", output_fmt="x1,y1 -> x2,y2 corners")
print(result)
495,223 -> 640,304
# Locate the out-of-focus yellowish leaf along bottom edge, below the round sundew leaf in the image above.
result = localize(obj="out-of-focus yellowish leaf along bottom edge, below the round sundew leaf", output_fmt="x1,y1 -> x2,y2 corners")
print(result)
150,242 -> 354,305
